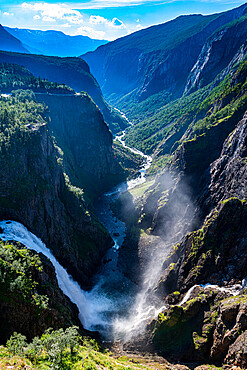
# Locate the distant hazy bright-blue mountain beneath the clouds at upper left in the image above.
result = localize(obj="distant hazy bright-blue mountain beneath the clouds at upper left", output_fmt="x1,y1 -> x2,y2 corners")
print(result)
4,27 -> 108,57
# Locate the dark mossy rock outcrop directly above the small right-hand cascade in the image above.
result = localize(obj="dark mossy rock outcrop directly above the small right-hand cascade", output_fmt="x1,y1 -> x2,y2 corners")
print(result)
156,198 -> 247,296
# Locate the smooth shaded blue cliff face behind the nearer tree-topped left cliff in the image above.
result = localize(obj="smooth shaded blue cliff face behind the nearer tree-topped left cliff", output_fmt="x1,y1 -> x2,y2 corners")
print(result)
36,94 -> 125,198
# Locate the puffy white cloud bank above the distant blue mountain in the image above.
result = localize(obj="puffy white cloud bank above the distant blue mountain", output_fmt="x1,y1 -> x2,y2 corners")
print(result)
6,0 -> 142,40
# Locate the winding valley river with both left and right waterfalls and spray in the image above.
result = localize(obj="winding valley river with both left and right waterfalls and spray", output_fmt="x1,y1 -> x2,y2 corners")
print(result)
0,129 -> 247,342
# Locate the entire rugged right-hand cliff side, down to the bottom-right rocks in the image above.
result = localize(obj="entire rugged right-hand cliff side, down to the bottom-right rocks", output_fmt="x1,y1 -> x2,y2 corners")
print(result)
120,63 -> 247,368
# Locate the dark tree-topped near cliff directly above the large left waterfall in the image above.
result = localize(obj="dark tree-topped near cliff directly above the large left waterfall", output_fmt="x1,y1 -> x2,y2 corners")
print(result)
0,98 -> 111,284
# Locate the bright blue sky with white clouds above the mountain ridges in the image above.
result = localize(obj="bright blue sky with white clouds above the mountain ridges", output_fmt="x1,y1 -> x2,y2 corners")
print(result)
0,0 -> 246,40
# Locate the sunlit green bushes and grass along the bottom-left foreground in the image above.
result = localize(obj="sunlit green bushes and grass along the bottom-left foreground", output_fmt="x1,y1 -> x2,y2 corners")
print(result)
0,326 -> 176,370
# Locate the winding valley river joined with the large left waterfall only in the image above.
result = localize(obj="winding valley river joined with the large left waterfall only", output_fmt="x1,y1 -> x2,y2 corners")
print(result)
0,132 -> 155,341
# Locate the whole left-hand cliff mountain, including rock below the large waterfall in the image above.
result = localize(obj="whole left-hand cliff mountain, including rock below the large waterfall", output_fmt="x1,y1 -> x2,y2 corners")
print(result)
0,63 -> 142,343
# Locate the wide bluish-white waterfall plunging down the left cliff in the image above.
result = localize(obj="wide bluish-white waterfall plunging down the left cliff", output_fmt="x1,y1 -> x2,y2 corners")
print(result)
0,221 -> 111,330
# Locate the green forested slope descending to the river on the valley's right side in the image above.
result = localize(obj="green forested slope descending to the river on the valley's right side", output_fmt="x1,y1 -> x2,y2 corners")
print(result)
126,61 -> 247,173
